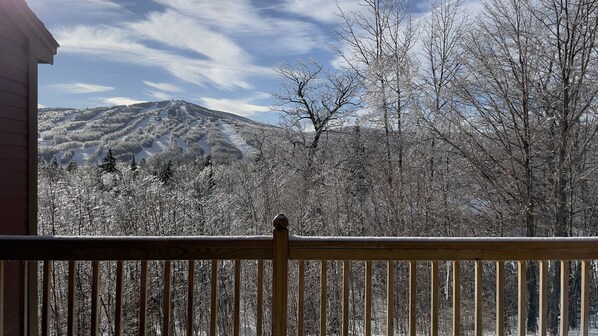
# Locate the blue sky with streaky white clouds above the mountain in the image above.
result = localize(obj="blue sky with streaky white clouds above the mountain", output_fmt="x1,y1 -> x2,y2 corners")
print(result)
27,0 -> 478,123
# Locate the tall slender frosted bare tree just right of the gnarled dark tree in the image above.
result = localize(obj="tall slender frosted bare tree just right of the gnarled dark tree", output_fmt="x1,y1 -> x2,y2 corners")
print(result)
332,0 -> 416,234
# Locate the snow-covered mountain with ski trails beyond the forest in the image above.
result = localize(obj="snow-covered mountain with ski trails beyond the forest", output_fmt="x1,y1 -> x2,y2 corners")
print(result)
38,100 -> 274,165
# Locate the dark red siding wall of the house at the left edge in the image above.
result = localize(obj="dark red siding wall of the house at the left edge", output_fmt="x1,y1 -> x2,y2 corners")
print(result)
0,18 -> 29,335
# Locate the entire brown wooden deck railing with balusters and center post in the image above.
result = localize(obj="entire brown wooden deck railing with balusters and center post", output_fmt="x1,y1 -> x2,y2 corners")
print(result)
0,215 -> 598,335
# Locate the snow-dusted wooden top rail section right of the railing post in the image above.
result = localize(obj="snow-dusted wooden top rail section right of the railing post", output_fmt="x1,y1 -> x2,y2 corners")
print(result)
289,236 -> 598,261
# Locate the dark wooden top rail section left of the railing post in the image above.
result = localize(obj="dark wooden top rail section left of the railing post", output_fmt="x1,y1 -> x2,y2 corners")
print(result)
0,236 -> 272,260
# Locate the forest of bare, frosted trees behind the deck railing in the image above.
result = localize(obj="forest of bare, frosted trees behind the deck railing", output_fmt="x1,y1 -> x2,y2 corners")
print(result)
39,0 -> 598,331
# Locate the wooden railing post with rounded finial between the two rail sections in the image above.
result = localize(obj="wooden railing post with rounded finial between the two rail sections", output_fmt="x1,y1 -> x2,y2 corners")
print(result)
272,214 -> 289,336
